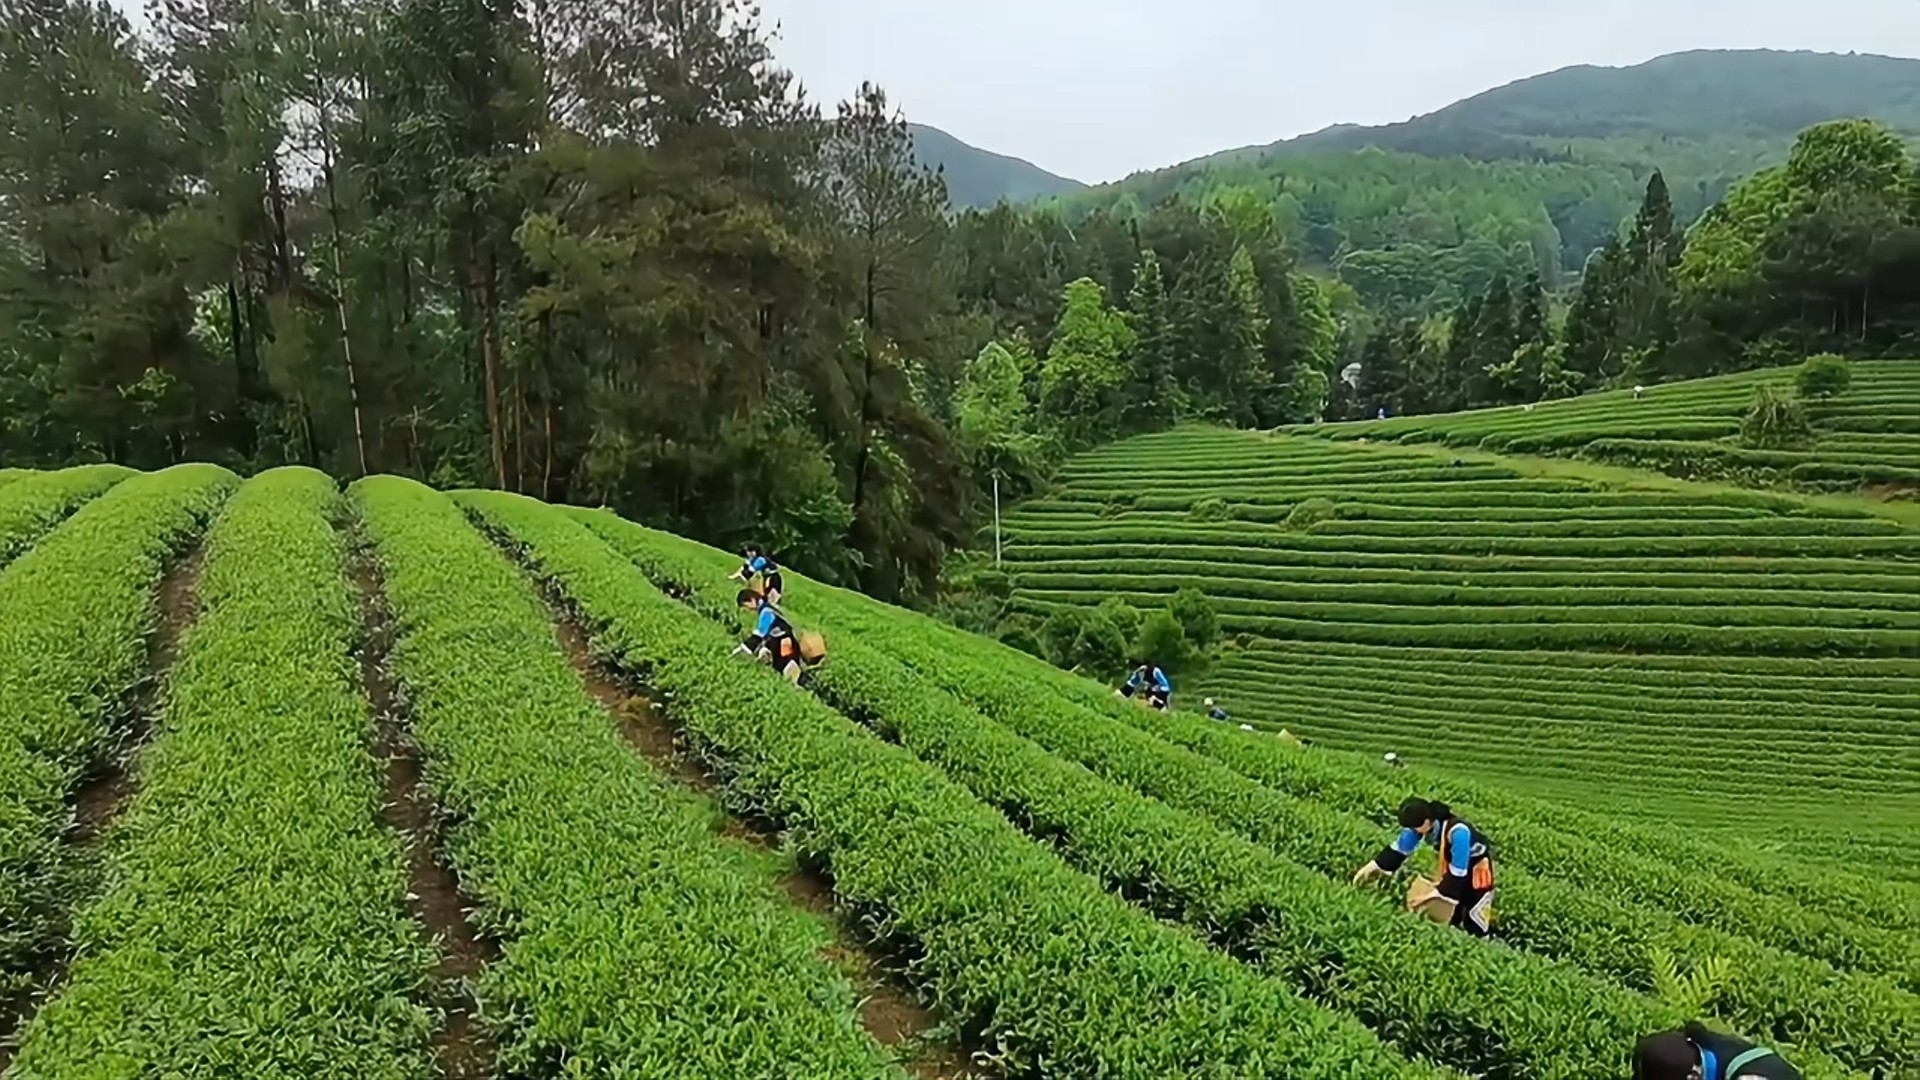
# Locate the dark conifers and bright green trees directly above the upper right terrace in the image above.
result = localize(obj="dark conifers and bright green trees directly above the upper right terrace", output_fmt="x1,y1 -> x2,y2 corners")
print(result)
1329,121 -> 1920,419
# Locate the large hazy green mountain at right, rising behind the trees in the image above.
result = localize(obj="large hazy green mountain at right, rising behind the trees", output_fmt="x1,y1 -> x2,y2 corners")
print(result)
1064,50 -> 1920,311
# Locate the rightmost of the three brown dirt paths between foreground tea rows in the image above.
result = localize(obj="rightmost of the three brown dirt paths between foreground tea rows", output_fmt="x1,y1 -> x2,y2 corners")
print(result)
543,611 -> 985,1080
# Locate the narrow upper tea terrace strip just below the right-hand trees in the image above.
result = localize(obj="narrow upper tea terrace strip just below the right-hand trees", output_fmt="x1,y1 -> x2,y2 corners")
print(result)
1290,359 -> 1920,492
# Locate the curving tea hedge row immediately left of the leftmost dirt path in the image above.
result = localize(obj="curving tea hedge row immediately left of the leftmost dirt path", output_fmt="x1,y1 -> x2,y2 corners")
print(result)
0,465 -> 236,992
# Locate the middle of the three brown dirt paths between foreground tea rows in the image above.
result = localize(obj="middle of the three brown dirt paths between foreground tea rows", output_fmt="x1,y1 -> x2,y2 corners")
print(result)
351,548 -> 499,1080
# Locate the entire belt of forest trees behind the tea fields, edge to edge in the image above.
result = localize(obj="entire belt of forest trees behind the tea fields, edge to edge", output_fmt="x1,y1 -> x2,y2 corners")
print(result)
0,0 -> 1920,600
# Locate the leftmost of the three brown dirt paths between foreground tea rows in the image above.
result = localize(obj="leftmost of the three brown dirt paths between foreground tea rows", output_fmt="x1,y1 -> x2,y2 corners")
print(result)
0,540 -> 205,1070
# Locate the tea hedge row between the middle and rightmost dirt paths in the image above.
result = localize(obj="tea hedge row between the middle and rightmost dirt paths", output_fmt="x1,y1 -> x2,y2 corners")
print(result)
353,477 -> 897,1078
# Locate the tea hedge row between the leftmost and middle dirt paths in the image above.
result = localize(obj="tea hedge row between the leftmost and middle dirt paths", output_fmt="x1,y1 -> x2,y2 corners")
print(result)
12,469 -> 432,1080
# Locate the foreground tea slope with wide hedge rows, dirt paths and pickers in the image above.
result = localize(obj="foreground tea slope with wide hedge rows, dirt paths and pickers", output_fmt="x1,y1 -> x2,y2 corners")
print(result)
0,461 -> 1920,1080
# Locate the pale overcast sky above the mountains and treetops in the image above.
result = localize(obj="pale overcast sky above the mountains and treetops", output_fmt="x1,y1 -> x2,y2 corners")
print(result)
760,0 -> 1920,183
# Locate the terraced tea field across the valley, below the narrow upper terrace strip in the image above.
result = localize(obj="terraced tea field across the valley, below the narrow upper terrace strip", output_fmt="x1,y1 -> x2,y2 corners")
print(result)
1006,429 -> 1920,864
